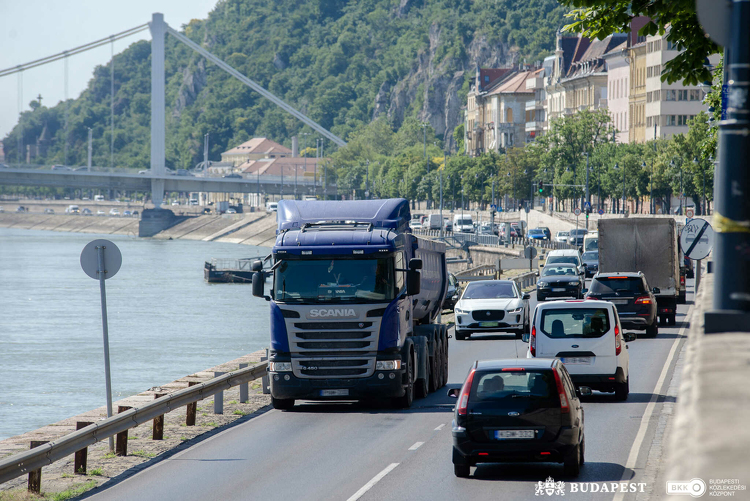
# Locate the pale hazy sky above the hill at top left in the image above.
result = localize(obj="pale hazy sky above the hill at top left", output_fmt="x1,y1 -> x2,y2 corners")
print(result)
0,0 -> 217,141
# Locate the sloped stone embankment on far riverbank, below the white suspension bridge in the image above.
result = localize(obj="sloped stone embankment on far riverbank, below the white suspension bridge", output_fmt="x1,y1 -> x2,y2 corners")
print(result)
0,212 -> 276,246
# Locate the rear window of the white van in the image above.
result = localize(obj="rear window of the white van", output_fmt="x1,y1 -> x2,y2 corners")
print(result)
541,308 -> 609,338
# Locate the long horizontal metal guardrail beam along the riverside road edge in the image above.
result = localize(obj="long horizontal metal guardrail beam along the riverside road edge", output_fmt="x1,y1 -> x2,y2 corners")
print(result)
0,362 -> 268,484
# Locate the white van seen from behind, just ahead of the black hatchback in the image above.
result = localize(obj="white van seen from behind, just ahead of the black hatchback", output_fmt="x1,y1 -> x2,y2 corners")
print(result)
524,300 -> 633,400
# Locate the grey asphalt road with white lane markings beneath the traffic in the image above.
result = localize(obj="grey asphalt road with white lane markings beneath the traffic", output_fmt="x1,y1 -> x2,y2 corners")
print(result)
87,287 -> 692,501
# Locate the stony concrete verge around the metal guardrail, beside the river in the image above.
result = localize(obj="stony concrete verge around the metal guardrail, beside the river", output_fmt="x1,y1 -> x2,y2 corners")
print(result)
0,350 -> 271,494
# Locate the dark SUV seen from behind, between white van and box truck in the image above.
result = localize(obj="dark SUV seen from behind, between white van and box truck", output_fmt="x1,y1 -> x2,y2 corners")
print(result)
586,272 -> 659,337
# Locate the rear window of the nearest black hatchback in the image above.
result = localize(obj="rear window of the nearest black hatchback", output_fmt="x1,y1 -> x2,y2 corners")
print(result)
469,369 -> 558,403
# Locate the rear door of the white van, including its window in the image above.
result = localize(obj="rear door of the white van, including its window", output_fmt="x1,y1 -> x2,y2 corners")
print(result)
536,303 -> 617,375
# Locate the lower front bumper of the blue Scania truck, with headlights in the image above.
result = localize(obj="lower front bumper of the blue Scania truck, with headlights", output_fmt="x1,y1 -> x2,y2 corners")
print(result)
268,369 -> 404,400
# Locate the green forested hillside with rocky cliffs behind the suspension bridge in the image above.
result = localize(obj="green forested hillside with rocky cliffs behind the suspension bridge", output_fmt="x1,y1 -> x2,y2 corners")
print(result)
3,0 -> 564,168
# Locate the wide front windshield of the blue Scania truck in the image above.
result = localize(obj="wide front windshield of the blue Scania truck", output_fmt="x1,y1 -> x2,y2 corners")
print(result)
273,258 -> 395,303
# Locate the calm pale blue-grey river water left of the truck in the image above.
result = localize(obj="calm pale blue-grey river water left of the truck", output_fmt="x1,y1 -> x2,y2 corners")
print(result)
0,228 -> 269,440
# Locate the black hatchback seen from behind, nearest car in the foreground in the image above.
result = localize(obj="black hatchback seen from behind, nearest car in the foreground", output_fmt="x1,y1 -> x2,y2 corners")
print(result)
448,358 -> 591,477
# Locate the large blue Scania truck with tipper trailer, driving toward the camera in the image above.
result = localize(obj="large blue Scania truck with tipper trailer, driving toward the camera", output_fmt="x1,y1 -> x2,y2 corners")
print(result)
253,199 -> 448,409
